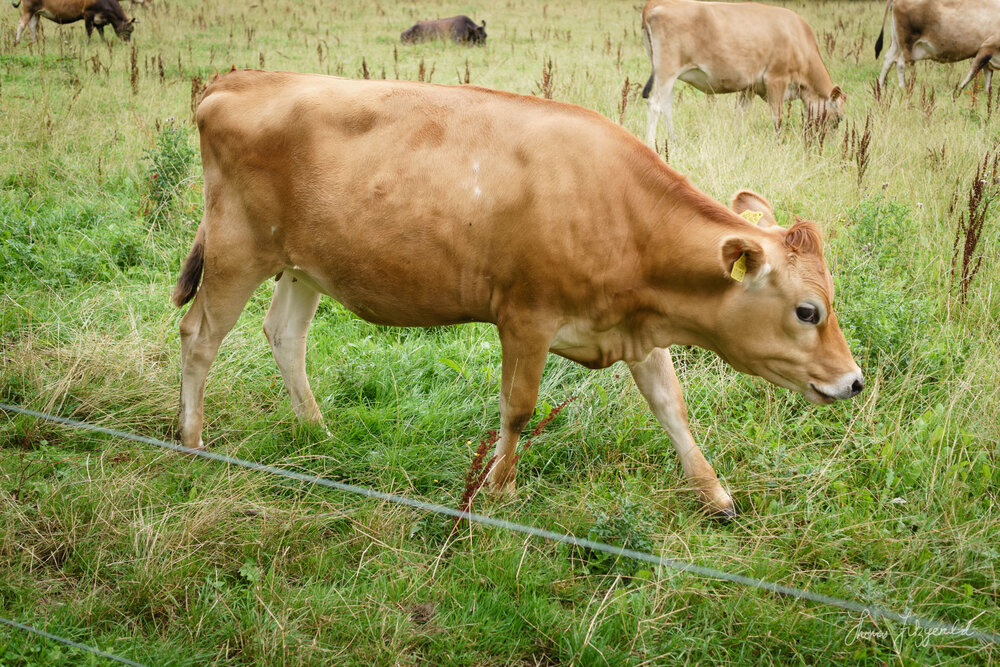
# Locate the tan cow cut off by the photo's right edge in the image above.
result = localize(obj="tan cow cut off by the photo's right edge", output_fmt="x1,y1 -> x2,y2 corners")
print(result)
875,0 -> 1000,97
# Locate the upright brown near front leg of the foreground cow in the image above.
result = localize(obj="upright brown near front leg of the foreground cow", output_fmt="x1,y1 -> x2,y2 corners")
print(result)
489,316 -> 552,493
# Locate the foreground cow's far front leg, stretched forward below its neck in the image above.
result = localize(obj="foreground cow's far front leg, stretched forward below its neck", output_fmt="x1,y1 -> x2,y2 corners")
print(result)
629,348 -> 736,517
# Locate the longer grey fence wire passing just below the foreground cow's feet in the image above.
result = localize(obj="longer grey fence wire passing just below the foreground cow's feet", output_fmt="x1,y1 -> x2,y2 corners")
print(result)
0,403 -> 1000,652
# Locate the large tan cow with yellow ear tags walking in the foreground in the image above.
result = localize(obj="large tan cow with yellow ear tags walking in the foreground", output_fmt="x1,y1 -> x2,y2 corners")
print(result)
173,71 -> 862,513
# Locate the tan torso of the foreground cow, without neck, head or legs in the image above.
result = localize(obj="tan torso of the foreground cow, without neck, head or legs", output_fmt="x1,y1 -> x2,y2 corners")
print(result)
198,71 -> 656,325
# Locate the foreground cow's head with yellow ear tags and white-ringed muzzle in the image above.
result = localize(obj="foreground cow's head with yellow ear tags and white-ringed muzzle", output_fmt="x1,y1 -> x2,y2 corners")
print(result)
715,190 -> 864,404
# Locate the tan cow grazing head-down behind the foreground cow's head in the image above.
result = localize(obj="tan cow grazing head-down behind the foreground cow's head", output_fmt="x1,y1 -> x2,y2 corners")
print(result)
642,0 -> 847,146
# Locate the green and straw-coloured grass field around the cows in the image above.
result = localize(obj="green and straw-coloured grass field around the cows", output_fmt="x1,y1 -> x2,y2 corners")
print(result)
0,0 -> 1000,667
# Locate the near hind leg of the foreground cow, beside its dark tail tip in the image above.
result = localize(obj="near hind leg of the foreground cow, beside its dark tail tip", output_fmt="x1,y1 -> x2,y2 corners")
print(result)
178,243 -> 274,449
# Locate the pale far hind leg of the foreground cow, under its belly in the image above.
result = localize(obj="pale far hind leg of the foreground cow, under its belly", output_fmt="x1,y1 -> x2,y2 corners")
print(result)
264,270 -> 323,425
